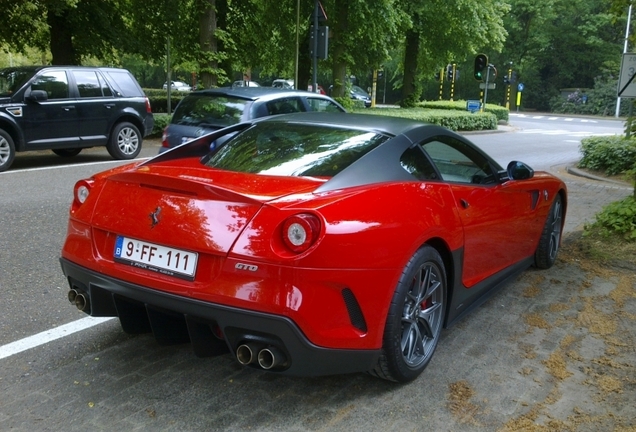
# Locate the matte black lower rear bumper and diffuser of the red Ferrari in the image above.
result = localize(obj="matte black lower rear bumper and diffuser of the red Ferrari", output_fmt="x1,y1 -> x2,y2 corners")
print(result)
60,258 -> 380,376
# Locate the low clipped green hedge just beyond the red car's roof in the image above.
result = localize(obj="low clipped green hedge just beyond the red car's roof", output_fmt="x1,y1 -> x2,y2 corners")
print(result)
354,108 -> 497,131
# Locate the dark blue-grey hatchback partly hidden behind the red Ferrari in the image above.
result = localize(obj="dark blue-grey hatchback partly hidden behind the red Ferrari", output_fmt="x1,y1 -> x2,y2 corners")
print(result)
159,87 -> 345,153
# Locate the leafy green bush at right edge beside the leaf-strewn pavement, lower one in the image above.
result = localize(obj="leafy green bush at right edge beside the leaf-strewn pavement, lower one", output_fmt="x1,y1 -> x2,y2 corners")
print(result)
586,196 -> 636,241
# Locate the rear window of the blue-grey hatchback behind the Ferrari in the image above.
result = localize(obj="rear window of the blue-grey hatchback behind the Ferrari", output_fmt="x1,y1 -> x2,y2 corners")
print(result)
172,94 -> 248,127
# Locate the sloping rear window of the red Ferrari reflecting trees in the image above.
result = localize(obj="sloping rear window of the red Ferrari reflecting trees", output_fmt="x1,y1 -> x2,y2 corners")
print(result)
205,122 -> 389,177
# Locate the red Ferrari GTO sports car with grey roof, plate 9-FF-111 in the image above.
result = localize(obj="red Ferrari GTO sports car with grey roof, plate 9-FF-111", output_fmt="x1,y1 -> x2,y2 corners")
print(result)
60,113 -> 567,382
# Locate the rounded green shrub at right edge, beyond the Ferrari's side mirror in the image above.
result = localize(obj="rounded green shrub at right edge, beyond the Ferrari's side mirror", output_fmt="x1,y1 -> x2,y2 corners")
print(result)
579,135 -> 636,175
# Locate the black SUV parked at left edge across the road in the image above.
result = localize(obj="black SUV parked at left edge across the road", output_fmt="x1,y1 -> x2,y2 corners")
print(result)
0,66 -> 154,172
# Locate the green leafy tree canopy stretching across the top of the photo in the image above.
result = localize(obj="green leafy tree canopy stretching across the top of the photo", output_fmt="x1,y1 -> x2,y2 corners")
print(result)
0,0 -> 631,108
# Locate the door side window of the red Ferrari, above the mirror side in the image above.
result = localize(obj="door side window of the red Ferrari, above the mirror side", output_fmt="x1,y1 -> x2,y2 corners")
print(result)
422,137 -> 495,184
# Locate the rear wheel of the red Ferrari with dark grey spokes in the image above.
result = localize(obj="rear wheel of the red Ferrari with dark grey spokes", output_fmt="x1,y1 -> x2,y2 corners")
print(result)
370,246 -> 446,382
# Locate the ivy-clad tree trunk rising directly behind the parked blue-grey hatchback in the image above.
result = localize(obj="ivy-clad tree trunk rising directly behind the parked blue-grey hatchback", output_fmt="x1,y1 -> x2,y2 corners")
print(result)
199,0 -> 219,88
